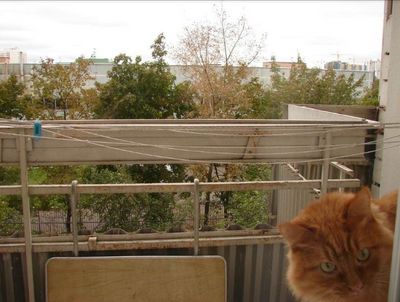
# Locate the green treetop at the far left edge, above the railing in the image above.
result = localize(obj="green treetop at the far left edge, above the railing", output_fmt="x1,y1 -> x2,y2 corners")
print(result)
0,75 -> 29,119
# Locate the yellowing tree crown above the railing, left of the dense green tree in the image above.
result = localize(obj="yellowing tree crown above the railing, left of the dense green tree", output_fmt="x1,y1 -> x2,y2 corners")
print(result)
32,57 -> 93,120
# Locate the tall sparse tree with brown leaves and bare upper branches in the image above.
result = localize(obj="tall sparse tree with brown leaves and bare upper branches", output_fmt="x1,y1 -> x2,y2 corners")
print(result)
174,8 -> 266,225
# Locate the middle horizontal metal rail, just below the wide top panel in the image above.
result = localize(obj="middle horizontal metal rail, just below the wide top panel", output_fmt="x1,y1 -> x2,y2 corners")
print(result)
0,179 -> 360,195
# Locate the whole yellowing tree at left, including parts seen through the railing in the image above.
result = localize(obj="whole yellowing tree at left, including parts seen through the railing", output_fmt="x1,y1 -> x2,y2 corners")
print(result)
32,57 -> 98,232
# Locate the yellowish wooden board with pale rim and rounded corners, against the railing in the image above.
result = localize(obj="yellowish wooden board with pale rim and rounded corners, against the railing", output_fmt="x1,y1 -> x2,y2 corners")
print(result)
46,256 -> 226,302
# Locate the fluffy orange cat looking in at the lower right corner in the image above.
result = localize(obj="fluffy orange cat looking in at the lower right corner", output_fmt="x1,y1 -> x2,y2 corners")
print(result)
279,188 -> 397,302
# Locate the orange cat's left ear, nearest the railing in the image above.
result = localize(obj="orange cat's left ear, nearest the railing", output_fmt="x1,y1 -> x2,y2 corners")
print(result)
279,222 -> 315,247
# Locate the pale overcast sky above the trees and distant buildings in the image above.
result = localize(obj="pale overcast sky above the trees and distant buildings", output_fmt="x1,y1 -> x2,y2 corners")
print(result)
0,1 -> 384,66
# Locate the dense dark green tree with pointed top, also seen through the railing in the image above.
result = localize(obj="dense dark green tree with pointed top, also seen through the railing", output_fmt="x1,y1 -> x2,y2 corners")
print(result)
92,34 -> 194,230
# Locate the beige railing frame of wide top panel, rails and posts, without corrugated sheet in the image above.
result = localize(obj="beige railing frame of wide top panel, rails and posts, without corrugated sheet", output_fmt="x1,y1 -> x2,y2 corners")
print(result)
0,120 -> 378,302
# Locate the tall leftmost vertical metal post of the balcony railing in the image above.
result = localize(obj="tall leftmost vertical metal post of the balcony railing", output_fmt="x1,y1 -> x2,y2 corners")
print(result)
18,129 -> 35,302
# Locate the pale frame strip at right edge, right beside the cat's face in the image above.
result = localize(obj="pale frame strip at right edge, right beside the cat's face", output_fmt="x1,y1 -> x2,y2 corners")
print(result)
388,188 -> 400,302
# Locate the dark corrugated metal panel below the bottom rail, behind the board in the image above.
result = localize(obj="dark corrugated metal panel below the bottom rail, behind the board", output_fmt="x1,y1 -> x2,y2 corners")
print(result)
0,245 -> 291,302
